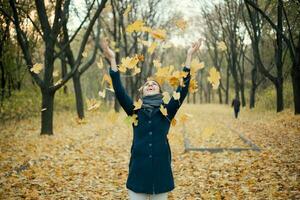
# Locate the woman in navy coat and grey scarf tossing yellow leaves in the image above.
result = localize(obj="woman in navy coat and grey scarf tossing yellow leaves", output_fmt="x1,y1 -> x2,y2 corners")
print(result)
101,40 -> 201,200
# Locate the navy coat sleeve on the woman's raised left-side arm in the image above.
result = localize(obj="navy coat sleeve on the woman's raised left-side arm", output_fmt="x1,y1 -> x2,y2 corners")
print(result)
109,67 -> 134,115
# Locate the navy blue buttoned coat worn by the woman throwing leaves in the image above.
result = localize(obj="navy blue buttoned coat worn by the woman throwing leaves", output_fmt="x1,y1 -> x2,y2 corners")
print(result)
109,67 -> 191,194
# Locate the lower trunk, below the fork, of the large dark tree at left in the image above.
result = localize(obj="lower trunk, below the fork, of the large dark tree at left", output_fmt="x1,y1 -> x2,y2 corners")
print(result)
41,88 -> 55,135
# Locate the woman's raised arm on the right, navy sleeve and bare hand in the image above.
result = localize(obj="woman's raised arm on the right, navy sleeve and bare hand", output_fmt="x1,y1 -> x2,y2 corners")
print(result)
166,39 -> 202,120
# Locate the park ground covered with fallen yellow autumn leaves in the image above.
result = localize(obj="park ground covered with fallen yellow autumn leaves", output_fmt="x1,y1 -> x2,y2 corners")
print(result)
0,104 -> 300,200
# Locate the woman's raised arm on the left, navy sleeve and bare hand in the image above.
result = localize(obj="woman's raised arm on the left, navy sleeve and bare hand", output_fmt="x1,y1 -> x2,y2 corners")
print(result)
101,40 -> 134,115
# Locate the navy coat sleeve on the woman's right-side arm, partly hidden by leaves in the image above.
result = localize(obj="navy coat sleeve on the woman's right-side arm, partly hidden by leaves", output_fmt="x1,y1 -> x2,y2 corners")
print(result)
166,67 -> 191,120
